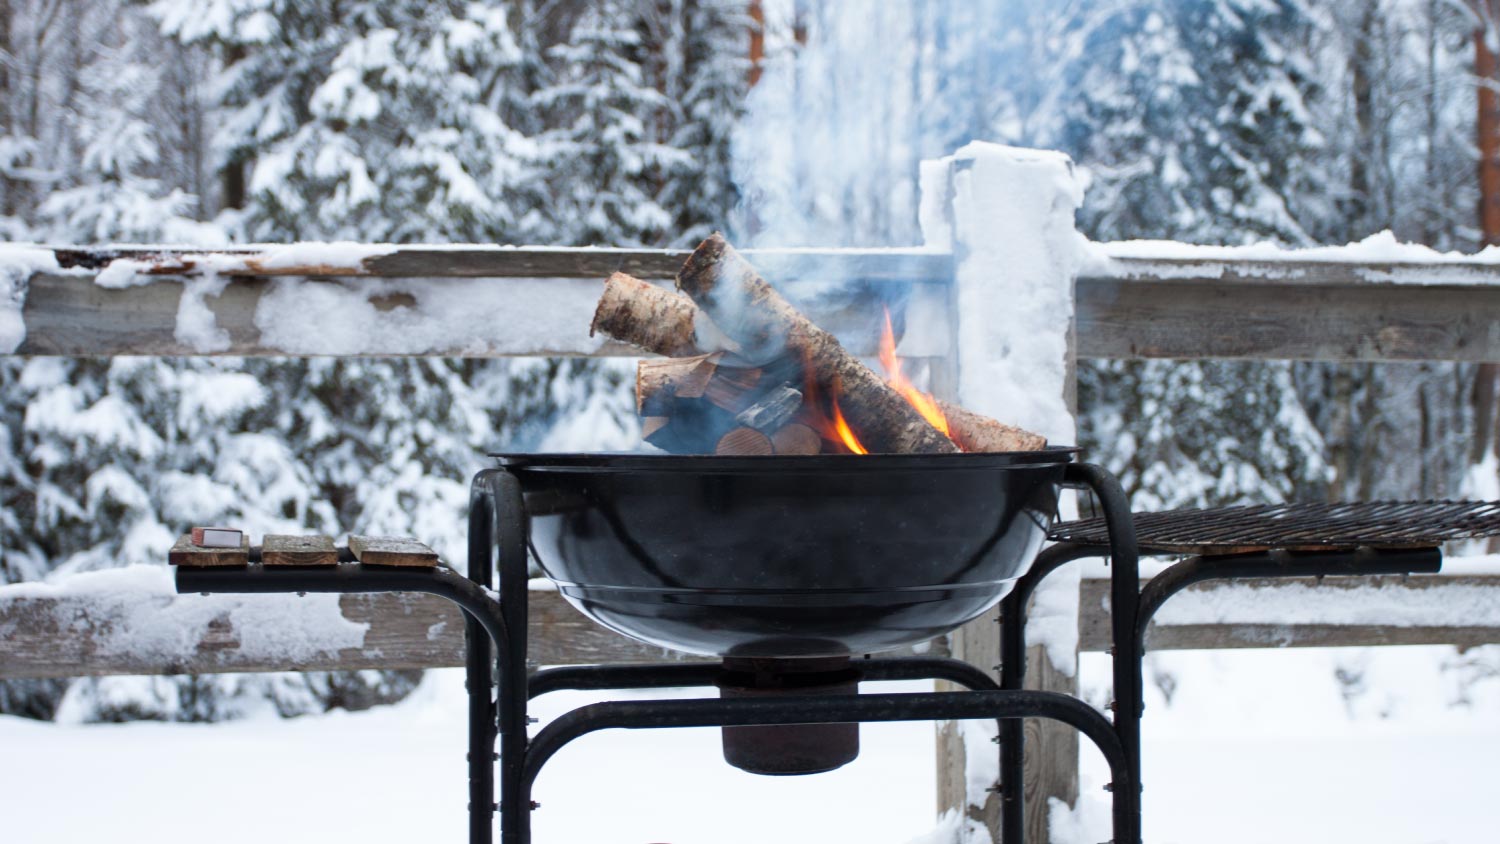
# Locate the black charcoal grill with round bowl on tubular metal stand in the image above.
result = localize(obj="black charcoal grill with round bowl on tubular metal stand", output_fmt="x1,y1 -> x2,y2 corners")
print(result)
177,461 -> 1500,844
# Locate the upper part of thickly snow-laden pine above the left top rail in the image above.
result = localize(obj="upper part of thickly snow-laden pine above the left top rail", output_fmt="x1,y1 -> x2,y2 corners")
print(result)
153,0 -> 531,241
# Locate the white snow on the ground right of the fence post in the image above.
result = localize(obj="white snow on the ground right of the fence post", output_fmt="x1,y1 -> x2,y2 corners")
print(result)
1074,648 -> 1500,844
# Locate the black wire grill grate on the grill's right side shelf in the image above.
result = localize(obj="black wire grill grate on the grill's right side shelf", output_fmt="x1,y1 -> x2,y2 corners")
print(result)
1049,501 -> 1500,553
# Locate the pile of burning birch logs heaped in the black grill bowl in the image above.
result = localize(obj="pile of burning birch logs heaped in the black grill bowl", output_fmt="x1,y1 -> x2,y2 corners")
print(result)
590,234 -> 1046,454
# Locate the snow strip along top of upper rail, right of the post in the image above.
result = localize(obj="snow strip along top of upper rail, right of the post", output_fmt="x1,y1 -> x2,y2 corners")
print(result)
1080,231 -> 1500,285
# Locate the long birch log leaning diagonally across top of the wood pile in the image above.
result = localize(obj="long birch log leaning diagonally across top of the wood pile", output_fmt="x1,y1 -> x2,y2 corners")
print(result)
677,234 -> 959,454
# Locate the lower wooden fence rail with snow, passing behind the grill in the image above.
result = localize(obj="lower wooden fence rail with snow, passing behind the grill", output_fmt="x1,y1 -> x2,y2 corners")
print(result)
0,567 -> 1500,679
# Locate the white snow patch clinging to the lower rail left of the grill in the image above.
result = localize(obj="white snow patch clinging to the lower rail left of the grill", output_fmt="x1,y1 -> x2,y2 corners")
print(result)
0,565 -> 369,664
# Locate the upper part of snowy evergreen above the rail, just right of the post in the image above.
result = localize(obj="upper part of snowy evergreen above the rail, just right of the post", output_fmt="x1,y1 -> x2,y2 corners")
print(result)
1062,0 -> 1322,246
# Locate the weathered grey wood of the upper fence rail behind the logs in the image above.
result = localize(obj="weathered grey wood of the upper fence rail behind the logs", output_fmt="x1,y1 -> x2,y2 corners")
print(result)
17,244 -> 1500,361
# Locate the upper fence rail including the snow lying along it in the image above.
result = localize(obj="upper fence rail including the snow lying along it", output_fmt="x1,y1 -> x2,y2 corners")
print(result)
0,241 -> 1500,361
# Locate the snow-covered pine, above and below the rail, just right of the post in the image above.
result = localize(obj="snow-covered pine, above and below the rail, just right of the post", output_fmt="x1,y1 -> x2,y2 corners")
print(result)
1065,0 -> 1328,508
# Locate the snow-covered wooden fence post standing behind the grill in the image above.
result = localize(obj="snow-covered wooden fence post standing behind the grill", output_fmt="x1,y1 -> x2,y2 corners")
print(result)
923,144 -> 1083,841
